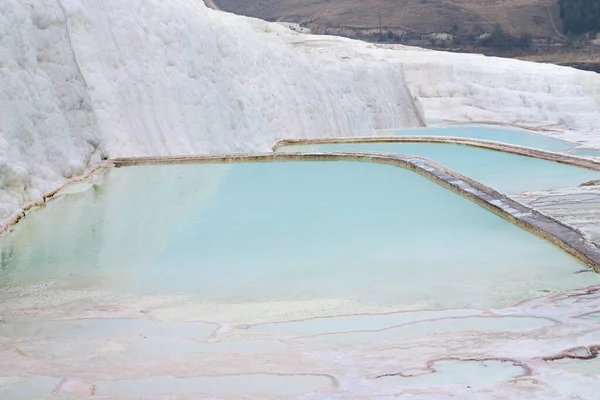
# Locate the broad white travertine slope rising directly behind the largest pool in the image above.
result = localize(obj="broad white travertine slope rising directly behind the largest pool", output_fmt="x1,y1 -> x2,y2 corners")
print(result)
62,0 -> 420,156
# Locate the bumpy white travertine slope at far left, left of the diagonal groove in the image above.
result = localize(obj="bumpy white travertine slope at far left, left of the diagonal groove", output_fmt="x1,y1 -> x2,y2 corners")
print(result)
0,0 -> 100,218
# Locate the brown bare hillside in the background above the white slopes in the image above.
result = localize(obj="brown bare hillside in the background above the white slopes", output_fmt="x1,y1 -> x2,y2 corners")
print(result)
215,0 -> 562,39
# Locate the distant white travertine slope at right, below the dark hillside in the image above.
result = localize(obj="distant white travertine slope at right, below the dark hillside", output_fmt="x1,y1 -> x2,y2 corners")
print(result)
322,38 -> 600,146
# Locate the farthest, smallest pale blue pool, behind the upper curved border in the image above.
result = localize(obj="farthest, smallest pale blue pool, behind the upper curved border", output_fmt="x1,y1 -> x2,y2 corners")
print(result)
379,125 -> 577,152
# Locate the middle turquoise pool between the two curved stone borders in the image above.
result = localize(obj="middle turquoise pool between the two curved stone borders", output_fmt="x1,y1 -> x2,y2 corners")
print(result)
277,142 -> 600,194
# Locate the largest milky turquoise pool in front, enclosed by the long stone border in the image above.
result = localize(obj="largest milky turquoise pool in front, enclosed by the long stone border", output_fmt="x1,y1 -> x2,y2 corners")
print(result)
0,162 -> 590,309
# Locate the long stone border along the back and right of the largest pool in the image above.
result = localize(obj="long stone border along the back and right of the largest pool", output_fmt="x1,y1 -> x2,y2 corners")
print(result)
111,152 -> 600,272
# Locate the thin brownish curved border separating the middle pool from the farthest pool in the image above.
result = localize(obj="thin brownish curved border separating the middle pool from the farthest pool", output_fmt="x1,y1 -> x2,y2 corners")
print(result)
272,136 -> 600,171
